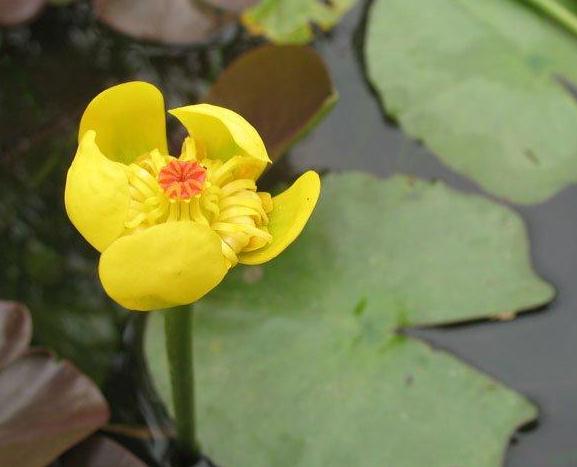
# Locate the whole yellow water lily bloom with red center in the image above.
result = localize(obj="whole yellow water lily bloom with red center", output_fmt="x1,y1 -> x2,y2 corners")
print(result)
65,82 -> 320,311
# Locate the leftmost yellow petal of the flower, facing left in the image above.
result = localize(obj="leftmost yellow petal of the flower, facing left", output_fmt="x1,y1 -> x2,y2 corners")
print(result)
64,131 -> 130,251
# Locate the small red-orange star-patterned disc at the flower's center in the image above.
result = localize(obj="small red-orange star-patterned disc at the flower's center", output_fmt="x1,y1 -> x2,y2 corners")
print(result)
158,160 -> 206,199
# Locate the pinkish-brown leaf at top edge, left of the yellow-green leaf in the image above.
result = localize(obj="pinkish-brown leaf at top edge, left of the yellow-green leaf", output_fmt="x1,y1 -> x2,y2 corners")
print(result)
92,0 -> 232,44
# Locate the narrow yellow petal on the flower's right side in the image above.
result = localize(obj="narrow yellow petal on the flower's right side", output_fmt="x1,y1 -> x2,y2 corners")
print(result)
239,170 -> 321,264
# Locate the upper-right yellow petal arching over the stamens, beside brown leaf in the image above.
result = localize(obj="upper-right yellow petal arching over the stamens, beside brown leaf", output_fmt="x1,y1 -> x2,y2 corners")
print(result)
169,104 -> 270,180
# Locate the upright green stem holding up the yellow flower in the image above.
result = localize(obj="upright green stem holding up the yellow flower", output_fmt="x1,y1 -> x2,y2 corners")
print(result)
164,306 -> 198,456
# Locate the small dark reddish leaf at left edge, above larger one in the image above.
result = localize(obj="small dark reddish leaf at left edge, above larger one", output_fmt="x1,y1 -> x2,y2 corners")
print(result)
0,302 -> 32,370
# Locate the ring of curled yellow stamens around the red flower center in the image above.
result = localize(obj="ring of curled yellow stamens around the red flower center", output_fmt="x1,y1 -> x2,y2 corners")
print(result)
125,138 -> 272,266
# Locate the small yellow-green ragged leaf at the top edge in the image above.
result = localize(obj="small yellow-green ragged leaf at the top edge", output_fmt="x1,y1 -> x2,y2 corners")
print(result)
242,0 -> 355,44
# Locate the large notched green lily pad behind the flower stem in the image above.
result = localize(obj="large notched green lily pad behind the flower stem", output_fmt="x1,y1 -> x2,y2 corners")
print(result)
146,174 -> 554,467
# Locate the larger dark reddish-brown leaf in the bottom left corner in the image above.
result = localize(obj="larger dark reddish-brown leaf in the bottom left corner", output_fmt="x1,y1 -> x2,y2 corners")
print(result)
0,351 -> 109,467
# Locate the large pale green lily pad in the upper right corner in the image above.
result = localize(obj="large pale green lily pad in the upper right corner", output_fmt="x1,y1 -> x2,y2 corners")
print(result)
366,0 -> 577,203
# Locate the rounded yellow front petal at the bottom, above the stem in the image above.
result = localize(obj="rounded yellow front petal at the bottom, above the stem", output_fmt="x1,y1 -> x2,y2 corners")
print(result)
98,222 -> 228,311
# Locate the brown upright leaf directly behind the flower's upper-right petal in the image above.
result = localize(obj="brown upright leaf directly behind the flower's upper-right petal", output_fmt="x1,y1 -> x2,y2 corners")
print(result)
205,45 -> 337,161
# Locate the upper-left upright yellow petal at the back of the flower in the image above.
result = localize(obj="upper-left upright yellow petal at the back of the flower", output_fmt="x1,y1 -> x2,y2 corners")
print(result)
78,81 -> 168,164
